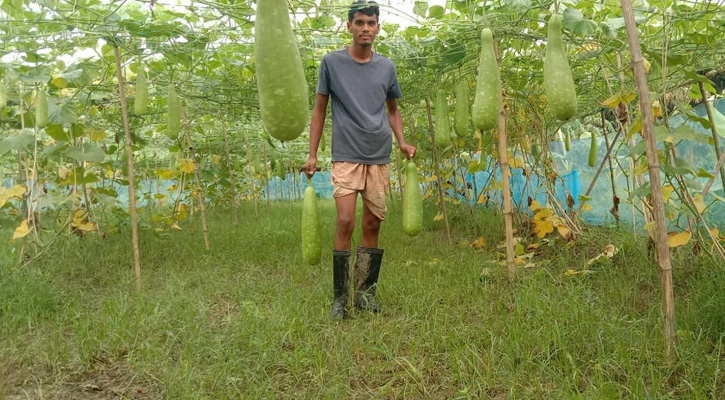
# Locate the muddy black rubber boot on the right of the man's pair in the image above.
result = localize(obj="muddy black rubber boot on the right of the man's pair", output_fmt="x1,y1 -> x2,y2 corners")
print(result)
353,246 -> 383,313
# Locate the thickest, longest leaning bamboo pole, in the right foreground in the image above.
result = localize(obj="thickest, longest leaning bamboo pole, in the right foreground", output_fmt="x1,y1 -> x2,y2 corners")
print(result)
622,0 -> 676,355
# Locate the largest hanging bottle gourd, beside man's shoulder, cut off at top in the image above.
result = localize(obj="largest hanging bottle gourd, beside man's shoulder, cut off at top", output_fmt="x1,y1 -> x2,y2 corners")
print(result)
254,0 -> 309,142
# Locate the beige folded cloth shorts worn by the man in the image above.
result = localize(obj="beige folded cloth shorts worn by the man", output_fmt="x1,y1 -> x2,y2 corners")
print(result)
332,161 -> 390,221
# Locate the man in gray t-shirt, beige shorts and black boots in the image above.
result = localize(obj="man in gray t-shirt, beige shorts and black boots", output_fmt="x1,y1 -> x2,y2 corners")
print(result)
302,0 -> 416,319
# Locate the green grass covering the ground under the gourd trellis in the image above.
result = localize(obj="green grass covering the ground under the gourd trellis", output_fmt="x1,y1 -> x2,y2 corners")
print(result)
0,201 -> 725,400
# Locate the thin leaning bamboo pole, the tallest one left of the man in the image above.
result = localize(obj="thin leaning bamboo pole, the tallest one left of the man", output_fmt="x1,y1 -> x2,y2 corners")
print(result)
113,46 -> 141,293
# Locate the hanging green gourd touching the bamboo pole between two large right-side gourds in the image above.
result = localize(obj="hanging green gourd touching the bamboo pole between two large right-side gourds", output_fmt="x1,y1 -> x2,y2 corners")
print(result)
472,28 -> 501,131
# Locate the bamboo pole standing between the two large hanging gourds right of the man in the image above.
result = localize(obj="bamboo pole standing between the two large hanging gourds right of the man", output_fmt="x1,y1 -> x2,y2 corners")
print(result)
493,40 -> 516,282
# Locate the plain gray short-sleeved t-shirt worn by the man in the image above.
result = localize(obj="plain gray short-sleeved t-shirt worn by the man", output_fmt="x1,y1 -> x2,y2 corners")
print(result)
317,49 -> 403,164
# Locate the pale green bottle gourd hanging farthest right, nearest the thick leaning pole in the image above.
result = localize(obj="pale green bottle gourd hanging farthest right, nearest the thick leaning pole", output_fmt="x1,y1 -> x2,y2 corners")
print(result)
544,14 -> 577,121
